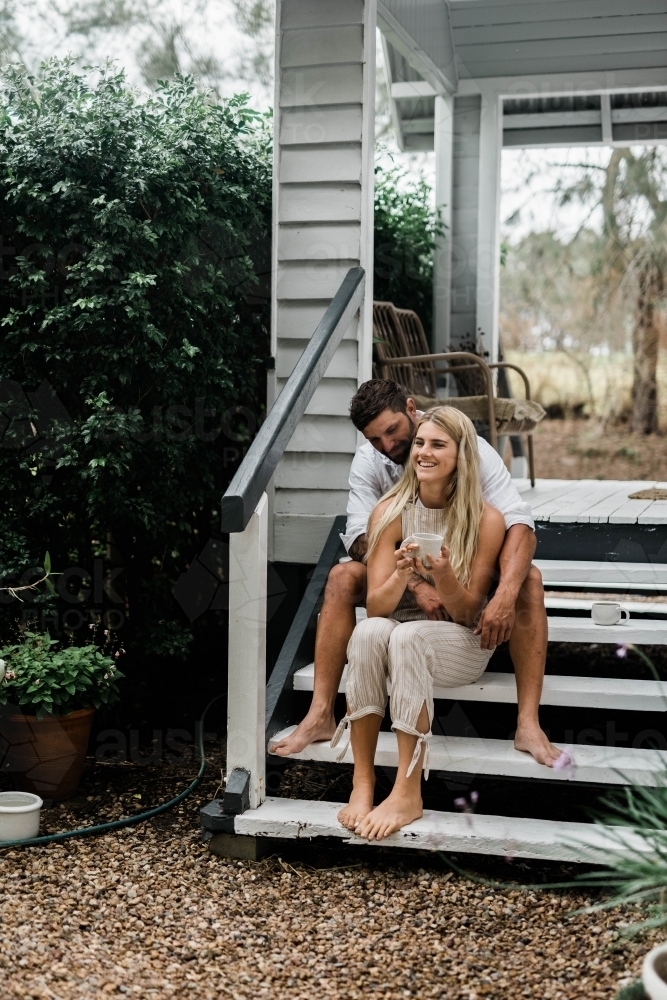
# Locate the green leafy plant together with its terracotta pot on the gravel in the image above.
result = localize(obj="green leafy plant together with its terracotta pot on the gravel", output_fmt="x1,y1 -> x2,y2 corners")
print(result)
0,625 -> 124,801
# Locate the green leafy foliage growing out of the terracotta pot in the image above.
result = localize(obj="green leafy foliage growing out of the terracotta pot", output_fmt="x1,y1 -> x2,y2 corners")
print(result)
0,629 -> 123,719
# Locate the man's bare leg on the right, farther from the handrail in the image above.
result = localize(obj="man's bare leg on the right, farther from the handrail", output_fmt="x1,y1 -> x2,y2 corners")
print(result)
510,566 -> 561,767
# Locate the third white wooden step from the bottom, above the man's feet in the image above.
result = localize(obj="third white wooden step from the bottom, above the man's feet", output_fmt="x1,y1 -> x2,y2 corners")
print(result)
294,663 -> 667,712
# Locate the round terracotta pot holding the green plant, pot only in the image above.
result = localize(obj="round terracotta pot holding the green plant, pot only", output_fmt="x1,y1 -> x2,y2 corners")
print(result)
0,708 -> 95,802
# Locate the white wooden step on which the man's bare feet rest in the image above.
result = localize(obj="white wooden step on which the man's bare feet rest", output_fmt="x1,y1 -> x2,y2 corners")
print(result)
269,726 -> 667,785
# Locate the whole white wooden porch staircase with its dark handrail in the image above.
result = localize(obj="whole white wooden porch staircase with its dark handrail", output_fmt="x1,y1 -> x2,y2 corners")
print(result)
201,268 -> 667,862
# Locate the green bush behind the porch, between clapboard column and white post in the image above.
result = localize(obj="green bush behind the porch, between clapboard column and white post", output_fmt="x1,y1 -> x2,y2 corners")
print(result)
373,166 -> 444,337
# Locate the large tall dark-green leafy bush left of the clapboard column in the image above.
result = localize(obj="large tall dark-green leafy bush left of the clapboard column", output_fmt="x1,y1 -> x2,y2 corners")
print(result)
0,61 -> 271,655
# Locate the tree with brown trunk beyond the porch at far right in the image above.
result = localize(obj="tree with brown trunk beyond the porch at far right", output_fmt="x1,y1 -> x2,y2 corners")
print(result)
560,146 -> 667,434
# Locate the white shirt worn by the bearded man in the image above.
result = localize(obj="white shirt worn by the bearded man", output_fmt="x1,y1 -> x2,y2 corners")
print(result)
340,436 -> 535,552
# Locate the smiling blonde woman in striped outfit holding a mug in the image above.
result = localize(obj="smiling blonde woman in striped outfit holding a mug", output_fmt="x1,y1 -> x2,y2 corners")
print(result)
331,406 -> 505,840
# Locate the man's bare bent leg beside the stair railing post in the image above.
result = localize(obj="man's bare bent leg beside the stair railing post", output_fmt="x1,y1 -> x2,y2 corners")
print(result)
271,562 -> 366,757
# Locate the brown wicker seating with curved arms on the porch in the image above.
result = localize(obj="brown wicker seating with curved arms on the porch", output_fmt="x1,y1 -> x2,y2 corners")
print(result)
373,302 -> 546,486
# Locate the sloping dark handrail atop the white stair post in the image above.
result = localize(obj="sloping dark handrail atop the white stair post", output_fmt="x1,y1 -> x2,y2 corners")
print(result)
221,267 -> 365,532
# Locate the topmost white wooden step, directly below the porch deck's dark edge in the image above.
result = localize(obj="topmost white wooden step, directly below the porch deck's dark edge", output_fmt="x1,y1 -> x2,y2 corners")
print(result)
533,559 -> 667,591
